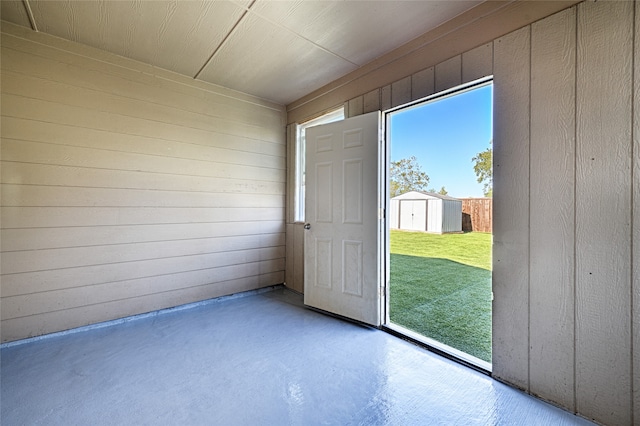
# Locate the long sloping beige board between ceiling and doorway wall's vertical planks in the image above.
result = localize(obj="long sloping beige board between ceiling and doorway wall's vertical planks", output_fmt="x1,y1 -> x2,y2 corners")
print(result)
287,0 -> 579,123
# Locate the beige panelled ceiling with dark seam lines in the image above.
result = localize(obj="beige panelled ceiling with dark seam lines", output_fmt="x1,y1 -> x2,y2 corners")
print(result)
0,0 -> 482,105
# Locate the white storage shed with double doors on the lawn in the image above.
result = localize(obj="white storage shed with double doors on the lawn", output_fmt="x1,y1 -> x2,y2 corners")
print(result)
389,191 -> 462,234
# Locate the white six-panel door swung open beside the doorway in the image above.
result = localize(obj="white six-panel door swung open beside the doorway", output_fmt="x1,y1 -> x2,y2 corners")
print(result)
304,112 -> 384,326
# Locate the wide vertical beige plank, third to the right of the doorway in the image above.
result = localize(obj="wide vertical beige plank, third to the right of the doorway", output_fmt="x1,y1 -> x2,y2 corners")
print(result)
576,2 -> 633,424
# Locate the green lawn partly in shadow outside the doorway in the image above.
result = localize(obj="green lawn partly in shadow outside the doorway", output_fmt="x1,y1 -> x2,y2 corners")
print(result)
389,230 -> 492,362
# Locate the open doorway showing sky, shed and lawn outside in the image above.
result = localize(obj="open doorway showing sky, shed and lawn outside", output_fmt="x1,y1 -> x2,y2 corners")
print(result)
387,79 -> 493,371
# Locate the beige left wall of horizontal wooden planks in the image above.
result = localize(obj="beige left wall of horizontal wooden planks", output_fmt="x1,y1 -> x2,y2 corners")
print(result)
1,22 -> 286,341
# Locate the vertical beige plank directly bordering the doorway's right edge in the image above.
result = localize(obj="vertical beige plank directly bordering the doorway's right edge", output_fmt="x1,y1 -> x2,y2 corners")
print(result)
492,27 -> 530,390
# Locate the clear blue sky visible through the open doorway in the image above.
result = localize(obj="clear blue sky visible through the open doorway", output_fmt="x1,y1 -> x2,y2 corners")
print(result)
390,85 -> 493,198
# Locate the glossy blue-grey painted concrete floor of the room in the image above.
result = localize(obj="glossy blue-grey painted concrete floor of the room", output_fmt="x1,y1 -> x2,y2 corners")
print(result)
0,288 -> 591,426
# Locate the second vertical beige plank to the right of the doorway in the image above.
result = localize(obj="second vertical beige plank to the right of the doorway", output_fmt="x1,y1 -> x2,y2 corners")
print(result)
530,8 -> 576,410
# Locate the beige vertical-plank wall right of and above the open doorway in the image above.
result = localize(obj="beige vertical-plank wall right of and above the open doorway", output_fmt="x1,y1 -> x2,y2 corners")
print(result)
289,1 -> 640,425
